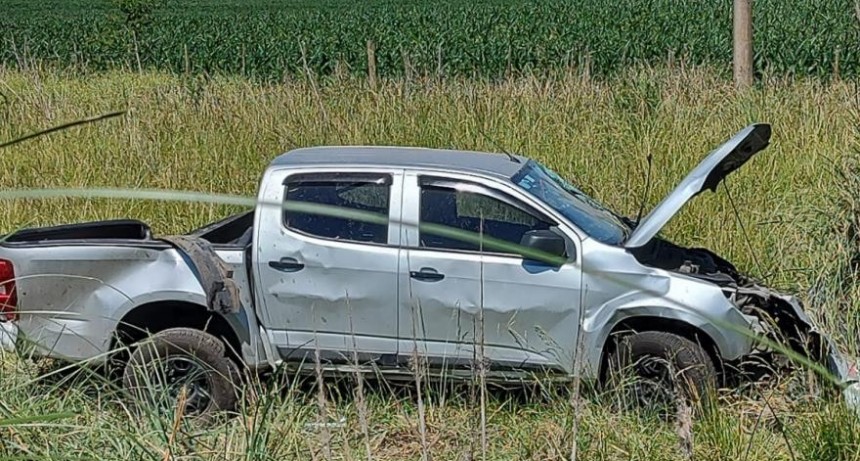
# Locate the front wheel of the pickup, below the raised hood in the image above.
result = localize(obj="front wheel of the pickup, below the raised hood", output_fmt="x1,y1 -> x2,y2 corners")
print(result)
608,331 -> 717,411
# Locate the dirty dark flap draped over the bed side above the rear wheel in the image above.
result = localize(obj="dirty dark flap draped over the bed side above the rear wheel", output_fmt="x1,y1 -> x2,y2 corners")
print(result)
161,235 -> 242,314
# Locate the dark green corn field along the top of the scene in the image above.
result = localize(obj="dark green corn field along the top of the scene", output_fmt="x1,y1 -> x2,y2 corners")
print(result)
0,0 -> 860,80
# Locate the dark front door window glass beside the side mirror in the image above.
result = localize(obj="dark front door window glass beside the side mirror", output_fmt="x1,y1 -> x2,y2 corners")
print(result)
419,178 -> 554,254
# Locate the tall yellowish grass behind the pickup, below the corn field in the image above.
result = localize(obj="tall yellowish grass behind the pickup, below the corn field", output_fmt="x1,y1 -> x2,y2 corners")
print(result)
0,65 -> 857,310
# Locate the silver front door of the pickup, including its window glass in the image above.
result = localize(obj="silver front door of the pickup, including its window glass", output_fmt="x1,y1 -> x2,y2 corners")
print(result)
400,173 -> 582,371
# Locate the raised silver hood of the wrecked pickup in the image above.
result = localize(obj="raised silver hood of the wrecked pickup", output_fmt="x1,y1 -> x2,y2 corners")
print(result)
624,123 -> 770,248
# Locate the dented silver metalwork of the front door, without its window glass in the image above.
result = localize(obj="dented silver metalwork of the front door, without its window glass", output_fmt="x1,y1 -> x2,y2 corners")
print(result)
400,173 -> 581,371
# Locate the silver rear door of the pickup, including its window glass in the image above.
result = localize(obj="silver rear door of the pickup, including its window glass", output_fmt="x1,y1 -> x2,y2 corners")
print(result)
254,168 -> 402,362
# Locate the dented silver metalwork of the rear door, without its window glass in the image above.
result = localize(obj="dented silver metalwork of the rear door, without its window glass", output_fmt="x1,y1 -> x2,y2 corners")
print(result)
254,168 -> 401,359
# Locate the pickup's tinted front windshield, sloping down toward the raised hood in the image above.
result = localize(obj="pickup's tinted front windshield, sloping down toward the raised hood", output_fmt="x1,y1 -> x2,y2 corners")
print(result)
511,160 -> 630,245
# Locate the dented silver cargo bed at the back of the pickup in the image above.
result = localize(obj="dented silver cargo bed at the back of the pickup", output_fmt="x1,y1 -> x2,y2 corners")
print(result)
0,213 -> 253,360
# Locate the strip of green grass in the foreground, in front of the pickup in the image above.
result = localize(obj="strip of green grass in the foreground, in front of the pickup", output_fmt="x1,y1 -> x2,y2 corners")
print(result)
0,350 -> 860,461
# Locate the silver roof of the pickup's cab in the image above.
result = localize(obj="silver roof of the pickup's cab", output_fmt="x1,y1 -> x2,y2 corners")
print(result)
272,146 -> 528,178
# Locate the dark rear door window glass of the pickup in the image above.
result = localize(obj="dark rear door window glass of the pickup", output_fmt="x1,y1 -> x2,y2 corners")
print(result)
284,173 -> 391,244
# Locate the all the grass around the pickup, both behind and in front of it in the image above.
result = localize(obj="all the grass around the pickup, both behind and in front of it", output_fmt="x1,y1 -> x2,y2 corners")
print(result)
0,63 -> 860,461
